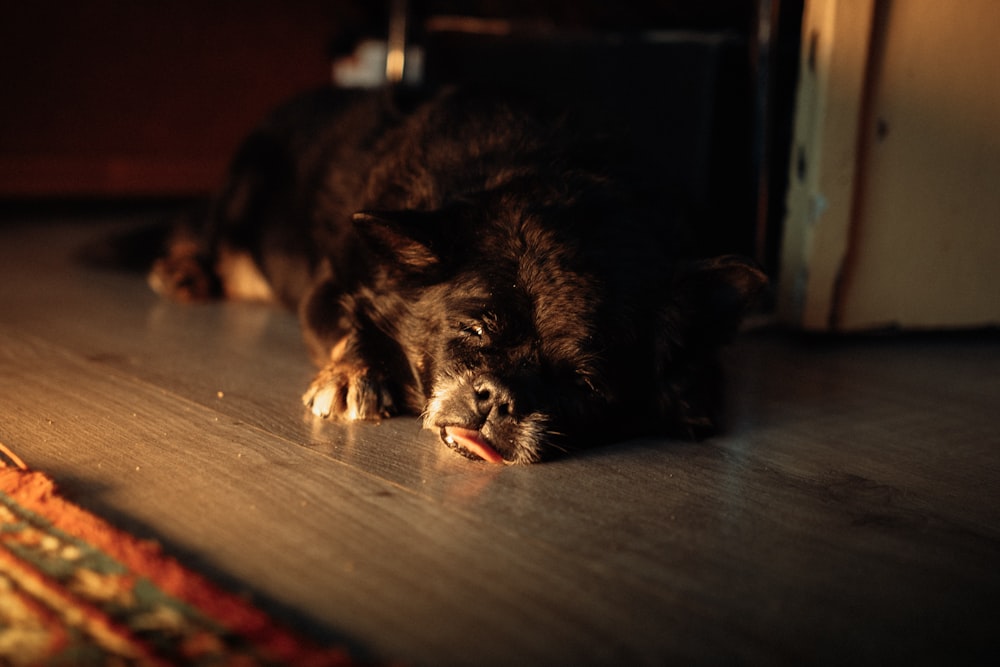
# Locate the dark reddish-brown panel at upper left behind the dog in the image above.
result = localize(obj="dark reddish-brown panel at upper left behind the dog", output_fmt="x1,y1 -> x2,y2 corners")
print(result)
0,0 -> 349,195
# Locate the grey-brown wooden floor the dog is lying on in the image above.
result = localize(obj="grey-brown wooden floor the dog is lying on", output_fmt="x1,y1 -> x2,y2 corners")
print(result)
0,207 -> 1000,665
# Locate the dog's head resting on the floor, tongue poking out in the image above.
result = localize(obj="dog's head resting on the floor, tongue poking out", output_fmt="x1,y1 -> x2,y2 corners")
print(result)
355,193 -> 765,463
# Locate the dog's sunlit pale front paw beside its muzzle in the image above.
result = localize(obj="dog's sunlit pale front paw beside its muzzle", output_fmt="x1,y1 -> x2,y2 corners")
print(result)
302,362 -> 395,421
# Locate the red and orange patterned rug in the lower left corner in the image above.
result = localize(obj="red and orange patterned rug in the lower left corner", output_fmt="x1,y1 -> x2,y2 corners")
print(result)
0,448 -> 354,667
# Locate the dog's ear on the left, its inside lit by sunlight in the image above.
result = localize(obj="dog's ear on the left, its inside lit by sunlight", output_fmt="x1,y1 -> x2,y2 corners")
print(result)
352,210 -> 456,274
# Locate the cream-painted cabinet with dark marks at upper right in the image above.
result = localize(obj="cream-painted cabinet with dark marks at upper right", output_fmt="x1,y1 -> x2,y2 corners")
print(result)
778,0 -> 1000,331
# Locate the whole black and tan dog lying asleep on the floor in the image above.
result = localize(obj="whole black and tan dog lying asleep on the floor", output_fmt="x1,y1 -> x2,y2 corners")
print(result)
152,85 -> 765,463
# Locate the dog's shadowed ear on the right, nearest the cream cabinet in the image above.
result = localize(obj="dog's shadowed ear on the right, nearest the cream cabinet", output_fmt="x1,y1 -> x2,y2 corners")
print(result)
672,255 -> 767,343
